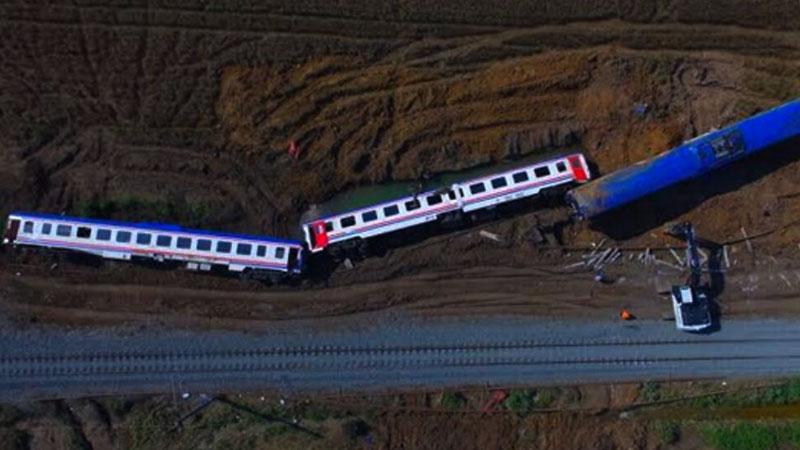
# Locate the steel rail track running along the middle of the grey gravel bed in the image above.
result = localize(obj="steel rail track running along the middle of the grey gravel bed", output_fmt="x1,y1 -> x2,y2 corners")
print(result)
0,338 -> 800,380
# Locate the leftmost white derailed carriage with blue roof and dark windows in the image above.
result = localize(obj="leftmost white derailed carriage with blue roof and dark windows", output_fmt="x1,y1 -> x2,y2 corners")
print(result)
3,212 -> 303,282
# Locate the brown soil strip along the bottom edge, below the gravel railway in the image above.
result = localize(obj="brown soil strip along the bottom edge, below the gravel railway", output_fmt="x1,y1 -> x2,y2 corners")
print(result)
6,381 -> 784,450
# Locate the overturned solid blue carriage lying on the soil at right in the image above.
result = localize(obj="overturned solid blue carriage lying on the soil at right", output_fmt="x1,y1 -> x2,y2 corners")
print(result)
567,100 -> 800,219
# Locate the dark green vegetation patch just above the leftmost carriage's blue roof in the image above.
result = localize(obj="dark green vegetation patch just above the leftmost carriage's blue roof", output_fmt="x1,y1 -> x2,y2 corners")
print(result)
74,196 -> 208,227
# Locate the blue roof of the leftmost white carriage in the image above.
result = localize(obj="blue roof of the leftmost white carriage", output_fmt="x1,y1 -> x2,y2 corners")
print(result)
9,211 -> 301,246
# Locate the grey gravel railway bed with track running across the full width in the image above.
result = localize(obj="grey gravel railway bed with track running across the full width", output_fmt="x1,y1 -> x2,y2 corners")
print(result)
0,322 -> 800,399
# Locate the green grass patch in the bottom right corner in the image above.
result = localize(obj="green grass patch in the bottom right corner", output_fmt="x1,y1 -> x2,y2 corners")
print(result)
700,422 -> 800,450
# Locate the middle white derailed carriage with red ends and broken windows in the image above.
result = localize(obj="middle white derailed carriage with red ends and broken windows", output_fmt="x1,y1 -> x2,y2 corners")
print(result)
301,153 -> 590,259
